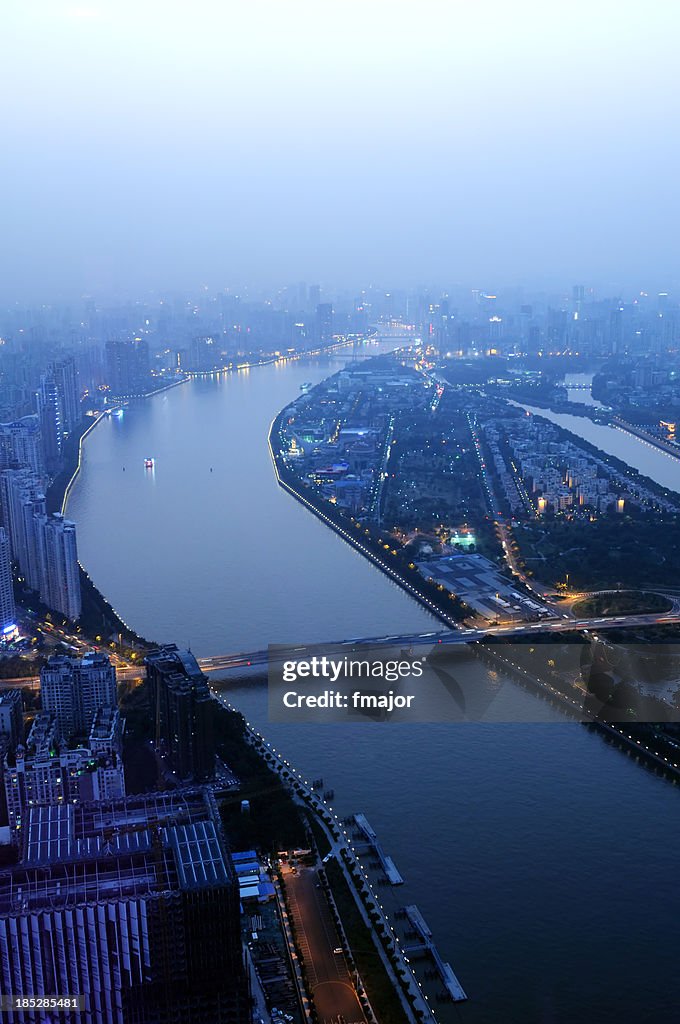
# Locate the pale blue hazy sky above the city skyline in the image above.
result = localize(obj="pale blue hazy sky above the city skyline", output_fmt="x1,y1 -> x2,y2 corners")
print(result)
0,0 -> 680,300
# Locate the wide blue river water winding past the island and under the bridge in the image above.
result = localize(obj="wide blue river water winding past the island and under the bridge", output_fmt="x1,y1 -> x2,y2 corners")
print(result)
69,349 -> 680,1024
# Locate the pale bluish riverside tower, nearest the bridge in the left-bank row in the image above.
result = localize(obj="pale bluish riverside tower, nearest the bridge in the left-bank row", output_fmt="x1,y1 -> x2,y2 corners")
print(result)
36,512 -> 81,622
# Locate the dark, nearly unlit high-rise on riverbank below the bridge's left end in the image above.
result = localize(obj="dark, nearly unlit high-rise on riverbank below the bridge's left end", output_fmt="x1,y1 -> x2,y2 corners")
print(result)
144,644 -> 215,781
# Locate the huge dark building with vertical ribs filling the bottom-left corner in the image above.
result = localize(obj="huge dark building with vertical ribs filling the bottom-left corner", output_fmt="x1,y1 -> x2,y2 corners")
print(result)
0,790 -> 252,1024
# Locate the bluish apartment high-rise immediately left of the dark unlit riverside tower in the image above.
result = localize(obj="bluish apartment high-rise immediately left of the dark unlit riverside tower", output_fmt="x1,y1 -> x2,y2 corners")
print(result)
40,651 -> 118,738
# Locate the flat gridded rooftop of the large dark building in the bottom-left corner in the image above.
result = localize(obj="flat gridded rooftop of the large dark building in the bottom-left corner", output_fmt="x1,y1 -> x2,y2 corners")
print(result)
0,788 -> 235,915
